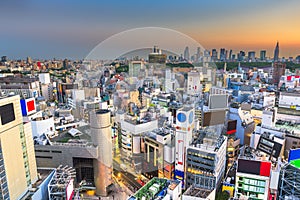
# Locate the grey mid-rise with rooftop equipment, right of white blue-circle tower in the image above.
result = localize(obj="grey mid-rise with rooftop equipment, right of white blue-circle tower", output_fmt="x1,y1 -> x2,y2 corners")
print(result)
185,129 -> 227,191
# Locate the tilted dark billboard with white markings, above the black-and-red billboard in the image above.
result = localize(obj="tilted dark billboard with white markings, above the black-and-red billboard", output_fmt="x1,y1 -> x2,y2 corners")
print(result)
256,136 -> 282,159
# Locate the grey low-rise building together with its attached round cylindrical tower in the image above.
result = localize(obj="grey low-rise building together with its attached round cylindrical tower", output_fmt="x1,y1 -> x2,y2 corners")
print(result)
35,110 -> 113,196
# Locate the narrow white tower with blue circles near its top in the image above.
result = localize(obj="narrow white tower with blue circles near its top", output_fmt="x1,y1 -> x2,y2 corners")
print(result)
175,107 -> 194,186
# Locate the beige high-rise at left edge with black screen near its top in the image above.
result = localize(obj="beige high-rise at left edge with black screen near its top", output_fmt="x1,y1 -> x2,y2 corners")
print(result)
0,96 -> 37,199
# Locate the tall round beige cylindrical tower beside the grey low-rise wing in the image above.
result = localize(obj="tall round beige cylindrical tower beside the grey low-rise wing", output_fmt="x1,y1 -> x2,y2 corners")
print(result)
90,110 -> 112,196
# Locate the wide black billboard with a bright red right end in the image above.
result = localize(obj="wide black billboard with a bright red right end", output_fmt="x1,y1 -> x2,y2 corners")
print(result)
237,159 -> 271,177
